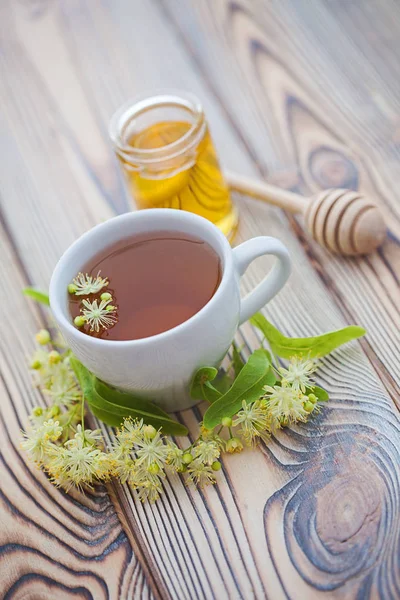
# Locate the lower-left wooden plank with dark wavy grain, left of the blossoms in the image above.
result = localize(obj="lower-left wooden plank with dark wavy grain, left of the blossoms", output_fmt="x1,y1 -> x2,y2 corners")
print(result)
0,218 -> 153,600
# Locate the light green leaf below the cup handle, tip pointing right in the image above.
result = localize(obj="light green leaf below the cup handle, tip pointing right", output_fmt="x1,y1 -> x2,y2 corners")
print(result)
250,313 -> 366,358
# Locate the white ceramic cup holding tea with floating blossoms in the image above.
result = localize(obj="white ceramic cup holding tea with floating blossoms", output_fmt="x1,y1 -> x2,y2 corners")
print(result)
50,209 -> 290,411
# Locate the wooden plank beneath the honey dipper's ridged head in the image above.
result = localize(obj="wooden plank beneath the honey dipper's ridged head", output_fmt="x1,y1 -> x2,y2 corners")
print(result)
160,0 -> 400,402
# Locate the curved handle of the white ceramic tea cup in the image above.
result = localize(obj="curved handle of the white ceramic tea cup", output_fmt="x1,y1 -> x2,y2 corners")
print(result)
233,236 -> 291,325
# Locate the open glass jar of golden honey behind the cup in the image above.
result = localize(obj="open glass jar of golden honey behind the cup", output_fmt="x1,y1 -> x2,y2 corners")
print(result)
110,92 -> 238,240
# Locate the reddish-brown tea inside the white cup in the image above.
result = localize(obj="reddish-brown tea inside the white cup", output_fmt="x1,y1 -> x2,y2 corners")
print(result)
69,231 -> 222,340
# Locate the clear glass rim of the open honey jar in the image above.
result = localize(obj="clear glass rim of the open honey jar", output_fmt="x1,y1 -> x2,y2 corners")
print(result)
108,90 -> 205,163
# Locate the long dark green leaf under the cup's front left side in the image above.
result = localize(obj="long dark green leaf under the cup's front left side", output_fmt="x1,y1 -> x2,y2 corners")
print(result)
70,357 -> 188,436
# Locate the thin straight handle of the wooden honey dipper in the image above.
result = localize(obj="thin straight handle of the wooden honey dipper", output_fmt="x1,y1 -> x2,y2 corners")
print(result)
225,171 -> 308,213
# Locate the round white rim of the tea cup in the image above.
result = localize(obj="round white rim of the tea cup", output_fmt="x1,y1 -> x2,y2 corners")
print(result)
49,208 -> 233,348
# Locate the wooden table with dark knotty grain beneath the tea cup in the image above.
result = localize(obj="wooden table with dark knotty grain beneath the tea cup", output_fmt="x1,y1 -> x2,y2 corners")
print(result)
0,0 -> 400,600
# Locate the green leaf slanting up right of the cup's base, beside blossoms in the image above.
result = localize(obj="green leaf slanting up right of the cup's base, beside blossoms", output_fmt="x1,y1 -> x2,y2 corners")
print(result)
203,348 -> 276,429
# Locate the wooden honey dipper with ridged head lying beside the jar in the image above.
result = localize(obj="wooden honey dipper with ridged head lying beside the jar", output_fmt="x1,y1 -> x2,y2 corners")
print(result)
225,172 -> 386,256
